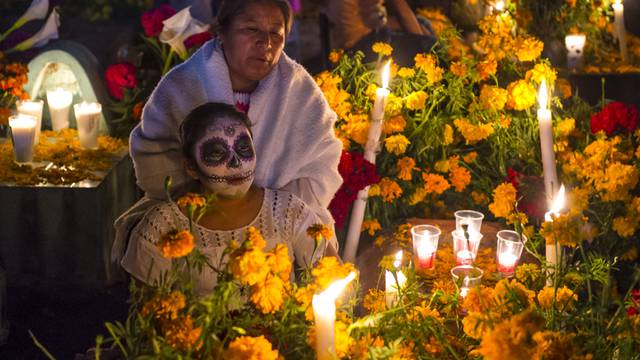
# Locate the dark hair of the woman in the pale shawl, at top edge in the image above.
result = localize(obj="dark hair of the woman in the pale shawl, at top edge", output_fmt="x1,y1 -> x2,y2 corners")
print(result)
213,0 -> 293,34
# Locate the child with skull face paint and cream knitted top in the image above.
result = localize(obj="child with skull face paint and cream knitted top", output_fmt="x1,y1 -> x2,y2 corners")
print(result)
121,102 -> 337,295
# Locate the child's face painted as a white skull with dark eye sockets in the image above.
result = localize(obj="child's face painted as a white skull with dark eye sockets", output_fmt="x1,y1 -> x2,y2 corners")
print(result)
193,117 -> 256,197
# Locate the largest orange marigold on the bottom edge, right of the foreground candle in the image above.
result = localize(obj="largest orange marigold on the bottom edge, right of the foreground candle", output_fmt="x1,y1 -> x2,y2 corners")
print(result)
478,310 -> 544,360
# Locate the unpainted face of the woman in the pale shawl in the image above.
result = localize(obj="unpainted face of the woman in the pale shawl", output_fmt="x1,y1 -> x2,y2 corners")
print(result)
220,2 -> 285,91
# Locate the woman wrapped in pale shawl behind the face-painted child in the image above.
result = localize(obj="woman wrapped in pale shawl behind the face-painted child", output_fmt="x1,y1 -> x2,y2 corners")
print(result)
112,0 -> 342,260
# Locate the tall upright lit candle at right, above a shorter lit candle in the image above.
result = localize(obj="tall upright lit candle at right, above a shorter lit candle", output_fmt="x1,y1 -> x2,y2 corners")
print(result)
538,79 -> 558,207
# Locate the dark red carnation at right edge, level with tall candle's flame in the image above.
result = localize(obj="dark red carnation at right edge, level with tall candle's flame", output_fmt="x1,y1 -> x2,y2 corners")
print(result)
591,101 -> 638,136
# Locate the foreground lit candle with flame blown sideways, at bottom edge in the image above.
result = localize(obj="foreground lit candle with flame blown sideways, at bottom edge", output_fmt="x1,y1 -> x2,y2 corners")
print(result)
311,272 -> 356,360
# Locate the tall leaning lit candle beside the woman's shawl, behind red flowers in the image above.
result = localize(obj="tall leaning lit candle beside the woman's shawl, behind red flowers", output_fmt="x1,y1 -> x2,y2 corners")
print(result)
342,61 -> 391,262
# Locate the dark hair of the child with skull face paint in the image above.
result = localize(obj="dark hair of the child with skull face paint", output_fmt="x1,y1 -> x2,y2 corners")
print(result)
180,102 -> 251,159
